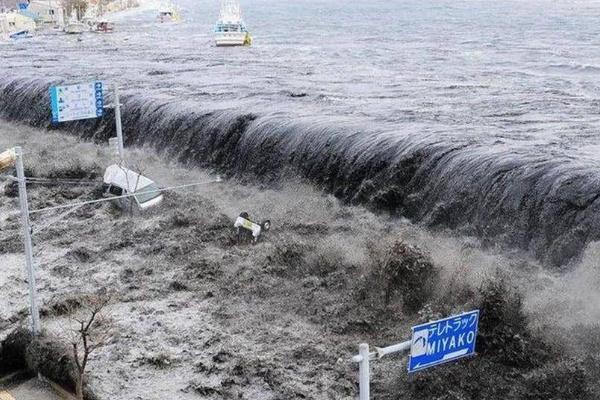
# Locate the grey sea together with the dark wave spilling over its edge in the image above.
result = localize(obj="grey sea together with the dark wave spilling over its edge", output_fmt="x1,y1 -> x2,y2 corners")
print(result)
0,0 -> 600,264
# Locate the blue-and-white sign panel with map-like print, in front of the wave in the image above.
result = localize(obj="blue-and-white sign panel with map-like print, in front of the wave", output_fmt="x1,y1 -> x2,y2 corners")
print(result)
50,81 -> 104,124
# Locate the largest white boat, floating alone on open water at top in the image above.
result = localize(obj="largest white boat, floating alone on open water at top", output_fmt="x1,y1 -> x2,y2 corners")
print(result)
214,0 -> 252,46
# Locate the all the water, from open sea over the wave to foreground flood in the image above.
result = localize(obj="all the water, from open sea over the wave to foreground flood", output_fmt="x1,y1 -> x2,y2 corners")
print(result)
0,4 -> 600,399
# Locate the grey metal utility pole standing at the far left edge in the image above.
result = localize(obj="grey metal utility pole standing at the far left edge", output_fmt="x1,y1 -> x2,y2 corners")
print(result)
14,147 -> 40,335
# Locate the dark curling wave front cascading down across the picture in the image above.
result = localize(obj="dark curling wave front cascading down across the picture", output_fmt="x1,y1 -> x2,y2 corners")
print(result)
0,79 -> 600,267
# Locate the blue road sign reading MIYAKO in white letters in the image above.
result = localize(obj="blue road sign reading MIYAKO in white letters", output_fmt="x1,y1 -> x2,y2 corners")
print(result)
408,310 -> 479,373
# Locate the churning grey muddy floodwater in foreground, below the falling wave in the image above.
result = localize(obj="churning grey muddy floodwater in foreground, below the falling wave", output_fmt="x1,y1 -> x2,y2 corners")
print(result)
0,121 -> 600,400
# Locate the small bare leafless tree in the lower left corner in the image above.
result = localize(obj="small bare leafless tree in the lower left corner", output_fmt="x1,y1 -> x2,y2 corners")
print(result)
69,296 -> 113,400
